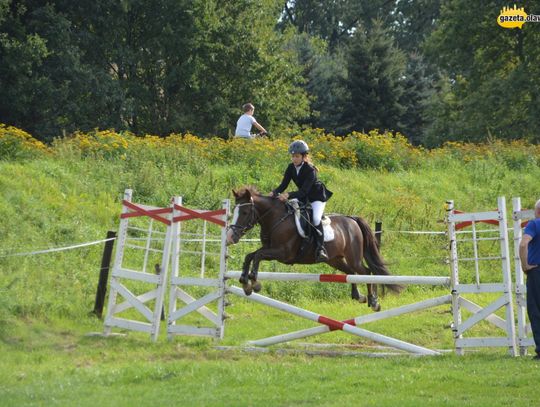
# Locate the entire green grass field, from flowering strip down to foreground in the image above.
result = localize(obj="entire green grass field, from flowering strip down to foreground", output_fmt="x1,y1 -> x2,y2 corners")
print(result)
0,135 -> 540,406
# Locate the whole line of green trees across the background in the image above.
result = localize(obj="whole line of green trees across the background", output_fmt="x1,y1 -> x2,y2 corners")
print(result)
0,0 -> 540,147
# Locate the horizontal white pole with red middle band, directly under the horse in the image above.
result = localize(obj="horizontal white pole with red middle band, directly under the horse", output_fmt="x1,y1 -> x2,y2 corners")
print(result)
225,271 -> 450,286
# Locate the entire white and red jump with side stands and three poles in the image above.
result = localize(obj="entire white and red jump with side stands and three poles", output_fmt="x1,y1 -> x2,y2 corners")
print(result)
104,190 -> 532,356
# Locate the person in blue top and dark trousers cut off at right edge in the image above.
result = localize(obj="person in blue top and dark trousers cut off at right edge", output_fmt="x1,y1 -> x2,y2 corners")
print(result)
519,200 -> 540,359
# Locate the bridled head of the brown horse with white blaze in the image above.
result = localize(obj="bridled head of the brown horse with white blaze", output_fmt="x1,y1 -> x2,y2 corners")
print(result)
227,187 -> 258,244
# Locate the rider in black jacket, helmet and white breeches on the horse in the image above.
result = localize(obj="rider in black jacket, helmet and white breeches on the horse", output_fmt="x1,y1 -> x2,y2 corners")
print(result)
270,140 -> 332,261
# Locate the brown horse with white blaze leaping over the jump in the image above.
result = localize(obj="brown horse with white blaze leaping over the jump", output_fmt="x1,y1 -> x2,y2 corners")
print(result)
227,186 -> 403,311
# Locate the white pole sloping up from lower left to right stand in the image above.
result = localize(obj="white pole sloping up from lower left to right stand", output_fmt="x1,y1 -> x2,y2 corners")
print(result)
248,294 -> 452,346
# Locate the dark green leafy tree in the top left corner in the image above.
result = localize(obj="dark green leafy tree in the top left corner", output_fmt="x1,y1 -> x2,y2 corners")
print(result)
0,1 -> 121,140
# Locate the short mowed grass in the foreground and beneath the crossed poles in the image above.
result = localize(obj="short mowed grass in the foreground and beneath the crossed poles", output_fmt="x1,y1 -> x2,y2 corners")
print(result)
0,294 -> 540,406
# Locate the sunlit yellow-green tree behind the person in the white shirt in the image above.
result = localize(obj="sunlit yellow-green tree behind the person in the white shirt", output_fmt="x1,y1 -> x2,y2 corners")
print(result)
184,0 -> 308,135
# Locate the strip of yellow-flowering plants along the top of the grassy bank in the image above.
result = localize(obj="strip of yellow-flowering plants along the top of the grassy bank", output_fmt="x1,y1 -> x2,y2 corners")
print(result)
4,124 -> 540,173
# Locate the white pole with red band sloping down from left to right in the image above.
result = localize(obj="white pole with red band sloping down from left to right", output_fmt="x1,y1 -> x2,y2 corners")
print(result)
227,286 -> 440,355
